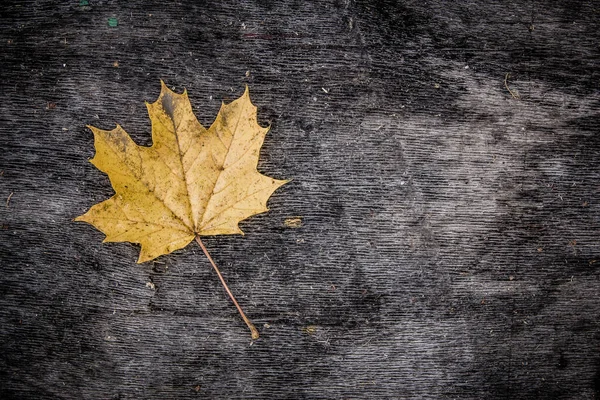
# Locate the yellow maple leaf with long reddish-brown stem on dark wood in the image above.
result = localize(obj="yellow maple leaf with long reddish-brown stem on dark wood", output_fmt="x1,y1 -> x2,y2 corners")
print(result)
75,81 -> 287,337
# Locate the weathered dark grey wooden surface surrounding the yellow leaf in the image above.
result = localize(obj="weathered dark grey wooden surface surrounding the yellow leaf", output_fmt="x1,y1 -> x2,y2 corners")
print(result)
0,0 -> 600,400
